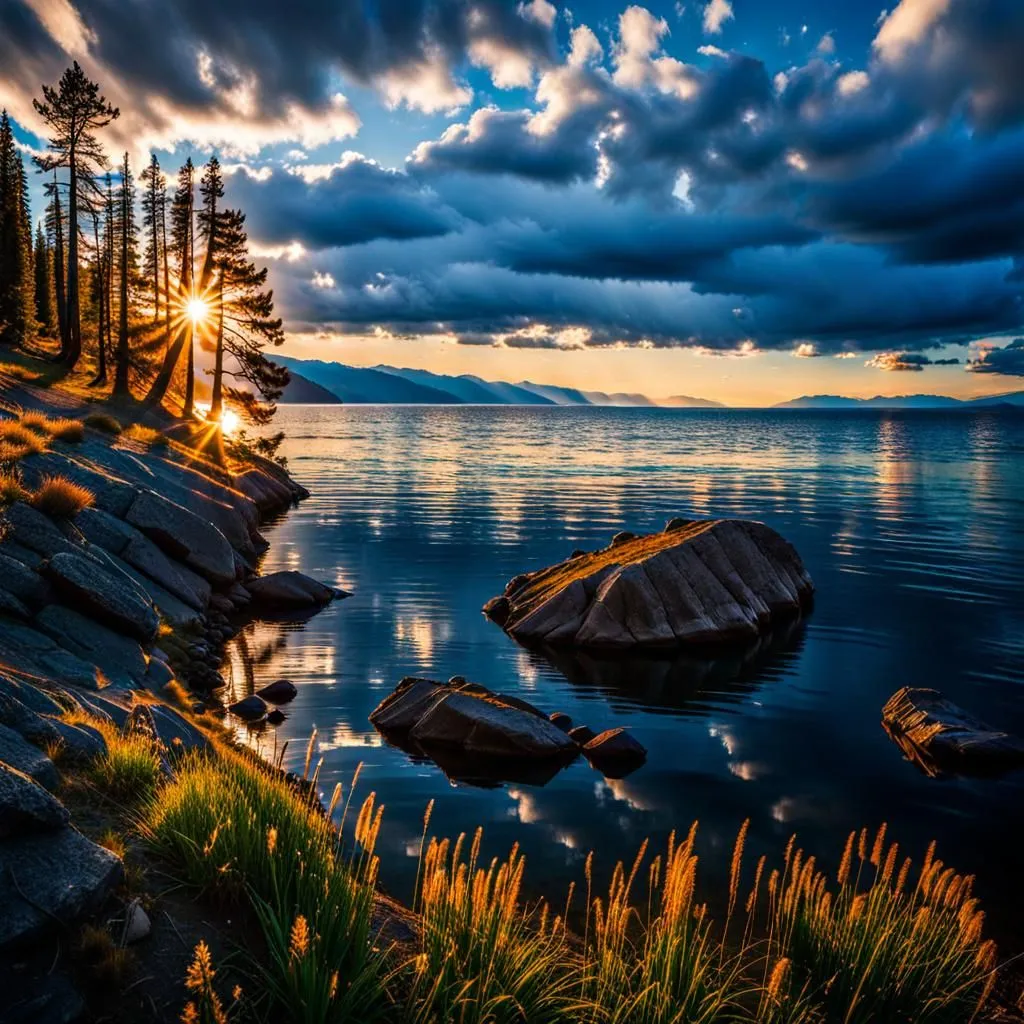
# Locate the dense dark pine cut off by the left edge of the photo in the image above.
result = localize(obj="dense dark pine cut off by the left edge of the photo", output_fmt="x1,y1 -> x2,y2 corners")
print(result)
0,111 -> 36,345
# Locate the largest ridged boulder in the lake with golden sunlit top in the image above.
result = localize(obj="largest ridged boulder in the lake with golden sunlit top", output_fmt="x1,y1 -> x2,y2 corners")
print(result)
483,519 -> 814,648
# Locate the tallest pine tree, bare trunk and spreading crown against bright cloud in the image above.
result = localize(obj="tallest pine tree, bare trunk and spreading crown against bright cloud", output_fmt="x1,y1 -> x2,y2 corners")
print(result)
33,60 -> 120,367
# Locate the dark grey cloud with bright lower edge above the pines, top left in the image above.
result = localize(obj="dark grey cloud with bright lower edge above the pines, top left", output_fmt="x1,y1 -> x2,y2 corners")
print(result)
0,0 -> 554,153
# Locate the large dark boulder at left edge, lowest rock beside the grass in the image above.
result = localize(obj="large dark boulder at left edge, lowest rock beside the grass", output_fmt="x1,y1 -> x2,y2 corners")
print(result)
0,827 -> 124,949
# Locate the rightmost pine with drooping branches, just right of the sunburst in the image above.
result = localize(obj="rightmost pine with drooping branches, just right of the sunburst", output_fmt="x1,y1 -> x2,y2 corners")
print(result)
210,210 -> 289,424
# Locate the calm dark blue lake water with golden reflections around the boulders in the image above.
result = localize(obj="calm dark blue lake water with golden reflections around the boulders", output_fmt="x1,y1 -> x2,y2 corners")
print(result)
233,407 -> 1024,932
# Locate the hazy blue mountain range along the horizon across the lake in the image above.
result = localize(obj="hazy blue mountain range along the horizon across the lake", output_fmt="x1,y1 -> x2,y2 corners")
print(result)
274,356 -> 1024,410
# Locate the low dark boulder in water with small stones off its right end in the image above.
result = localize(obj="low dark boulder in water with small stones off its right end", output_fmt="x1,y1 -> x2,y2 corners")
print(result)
370,677 -> 579,761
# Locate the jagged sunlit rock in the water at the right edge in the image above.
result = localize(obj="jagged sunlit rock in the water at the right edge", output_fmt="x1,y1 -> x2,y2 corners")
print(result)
882,686 -> 1024,775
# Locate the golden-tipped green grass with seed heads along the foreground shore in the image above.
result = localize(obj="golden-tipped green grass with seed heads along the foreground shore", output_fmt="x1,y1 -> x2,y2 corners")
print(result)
77,726 -> 996,1024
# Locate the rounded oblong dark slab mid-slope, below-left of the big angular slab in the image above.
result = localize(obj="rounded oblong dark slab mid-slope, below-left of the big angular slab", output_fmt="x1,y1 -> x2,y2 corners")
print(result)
46,552 -> 160,643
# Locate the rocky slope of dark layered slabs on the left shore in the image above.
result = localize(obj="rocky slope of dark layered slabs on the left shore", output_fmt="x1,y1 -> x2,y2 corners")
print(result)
0,379 -> 335,966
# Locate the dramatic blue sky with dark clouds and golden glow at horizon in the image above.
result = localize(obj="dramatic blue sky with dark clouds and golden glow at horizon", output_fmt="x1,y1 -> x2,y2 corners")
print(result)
0,0 -> 1024,404
